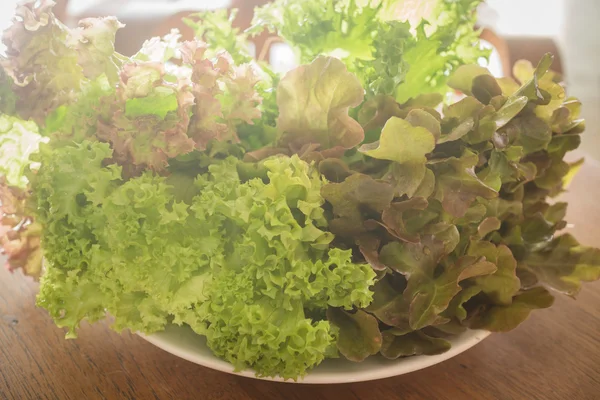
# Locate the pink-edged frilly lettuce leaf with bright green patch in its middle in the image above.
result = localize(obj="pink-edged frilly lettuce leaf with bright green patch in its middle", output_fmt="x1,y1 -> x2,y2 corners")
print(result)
96,63 -> 194,171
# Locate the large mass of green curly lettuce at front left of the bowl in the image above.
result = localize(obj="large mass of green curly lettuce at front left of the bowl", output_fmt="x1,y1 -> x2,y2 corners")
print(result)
33,141 -> 375,378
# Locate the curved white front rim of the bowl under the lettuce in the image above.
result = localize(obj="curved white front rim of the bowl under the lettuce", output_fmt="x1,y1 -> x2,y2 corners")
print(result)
137,327 -> 491,384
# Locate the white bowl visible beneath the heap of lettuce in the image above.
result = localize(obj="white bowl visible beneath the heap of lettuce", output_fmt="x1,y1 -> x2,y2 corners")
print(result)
140,325 -> 490,384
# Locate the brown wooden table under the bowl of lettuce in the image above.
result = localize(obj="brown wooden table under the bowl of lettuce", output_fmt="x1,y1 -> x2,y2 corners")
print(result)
0,154 -> 600,400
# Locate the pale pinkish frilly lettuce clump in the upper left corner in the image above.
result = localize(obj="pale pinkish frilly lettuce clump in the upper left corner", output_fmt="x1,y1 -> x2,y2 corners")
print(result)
0,0 -> 126,127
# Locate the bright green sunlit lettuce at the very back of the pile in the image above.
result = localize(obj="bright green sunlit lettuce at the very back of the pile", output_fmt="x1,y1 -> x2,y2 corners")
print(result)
249,0 -> 486,99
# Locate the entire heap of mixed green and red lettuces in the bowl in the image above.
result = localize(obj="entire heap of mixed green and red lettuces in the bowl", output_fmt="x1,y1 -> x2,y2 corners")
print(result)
0,0 -> 600,379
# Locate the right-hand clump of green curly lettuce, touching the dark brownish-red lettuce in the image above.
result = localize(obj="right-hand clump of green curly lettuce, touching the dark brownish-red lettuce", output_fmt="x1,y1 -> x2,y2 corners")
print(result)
180,157 -> 374,377
